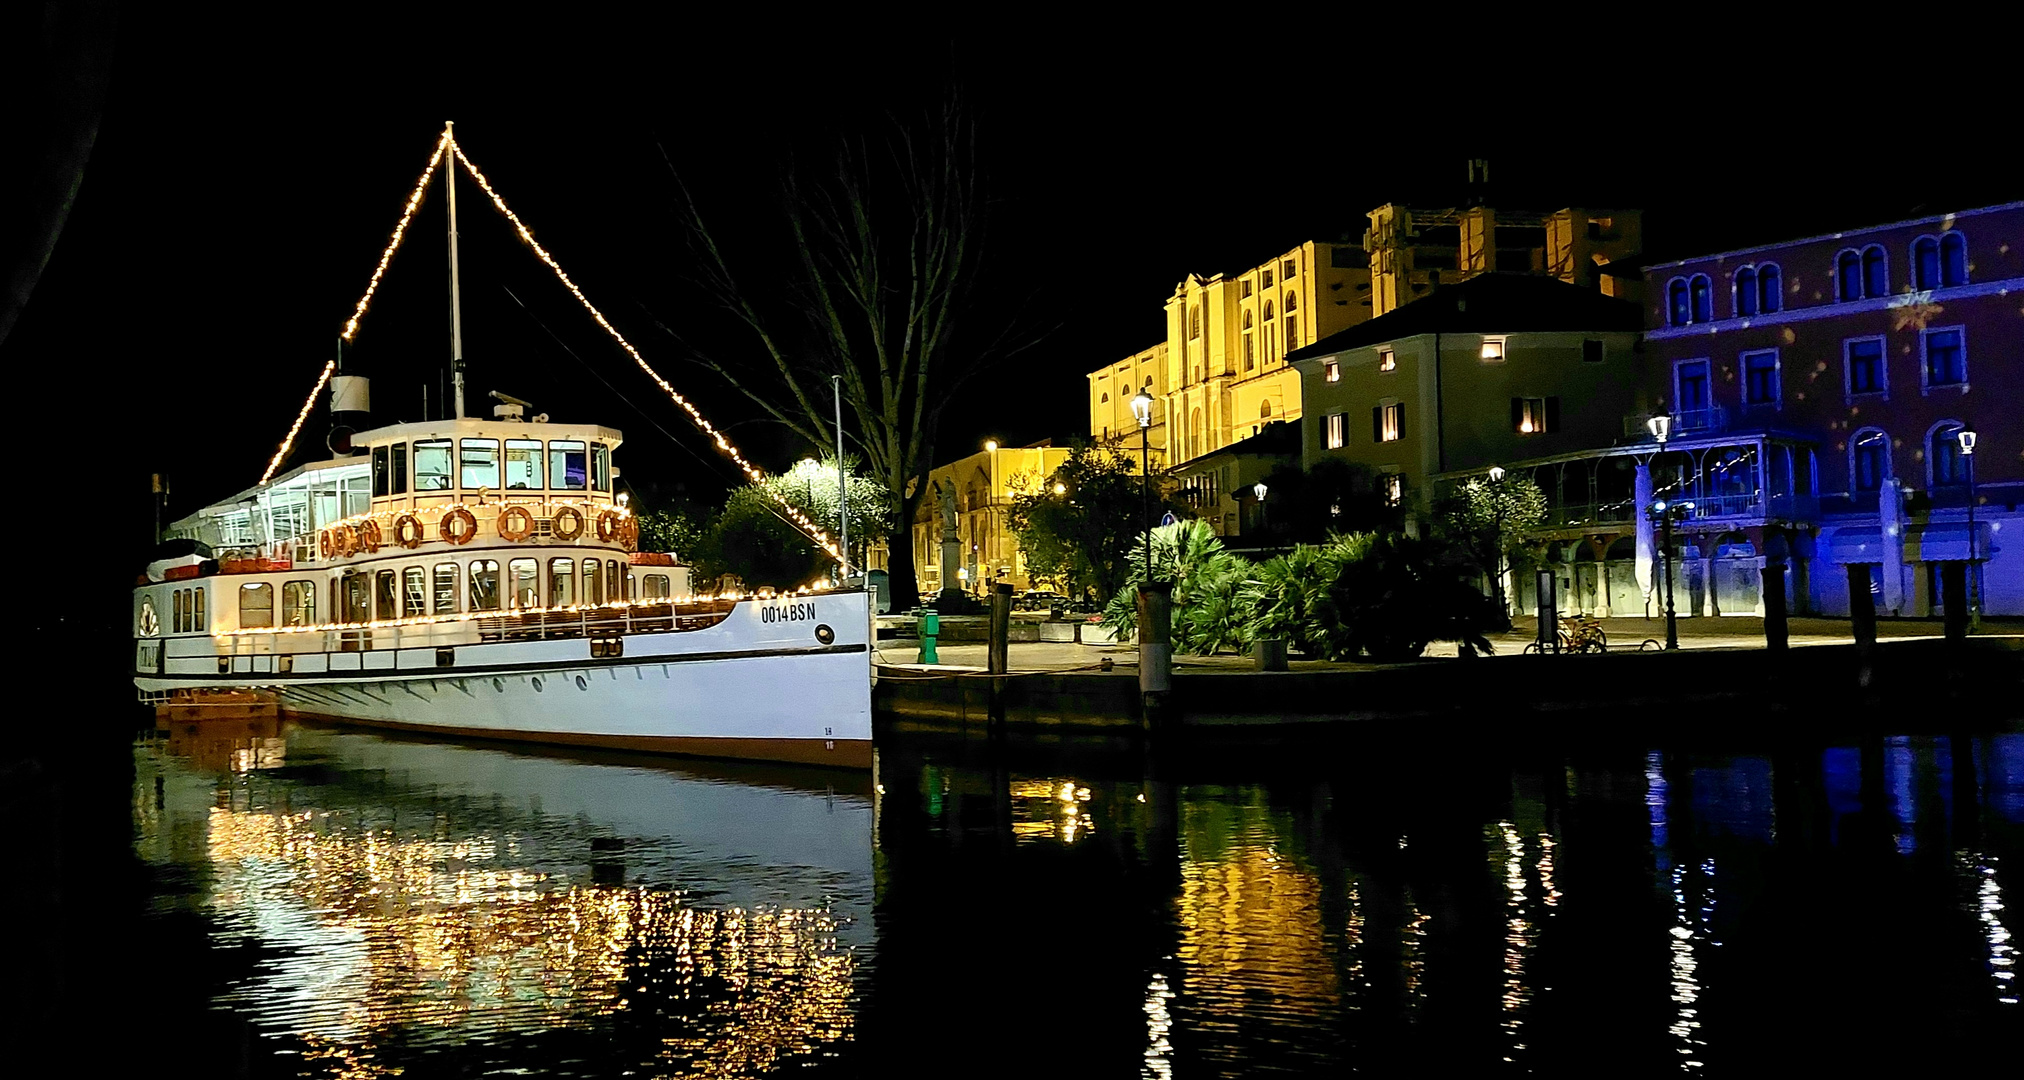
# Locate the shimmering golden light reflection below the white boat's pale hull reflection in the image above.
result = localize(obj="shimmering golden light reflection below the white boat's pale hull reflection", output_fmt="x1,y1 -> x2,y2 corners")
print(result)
178,788 -> 854,1076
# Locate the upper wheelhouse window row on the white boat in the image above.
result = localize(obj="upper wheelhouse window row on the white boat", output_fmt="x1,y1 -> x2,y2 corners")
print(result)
372,439 -> 611,498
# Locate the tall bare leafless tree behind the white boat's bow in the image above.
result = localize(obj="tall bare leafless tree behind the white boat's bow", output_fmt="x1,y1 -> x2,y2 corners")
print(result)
670,101 -> 1018,607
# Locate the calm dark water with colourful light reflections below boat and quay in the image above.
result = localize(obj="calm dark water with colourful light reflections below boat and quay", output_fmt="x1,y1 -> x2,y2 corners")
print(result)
118,724 -> 2024,1076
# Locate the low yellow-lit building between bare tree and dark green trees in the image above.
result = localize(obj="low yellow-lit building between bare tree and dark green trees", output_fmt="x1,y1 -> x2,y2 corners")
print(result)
913,440 -> 1076,597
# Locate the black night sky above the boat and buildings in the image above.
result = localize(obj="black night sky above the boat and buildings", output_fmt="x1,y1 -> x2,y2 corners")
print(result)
0,6 -> 2024,546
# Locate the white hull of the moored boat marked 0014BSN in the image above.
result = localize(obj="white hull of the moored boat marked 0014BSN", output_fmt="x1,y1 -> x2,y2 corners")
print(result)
136,595 -> 872,769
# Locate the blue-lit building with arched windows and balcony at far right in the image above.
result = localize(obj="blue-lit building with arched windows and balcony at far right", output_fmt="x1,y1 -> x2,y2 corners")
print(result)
1449,202 -> 2024,617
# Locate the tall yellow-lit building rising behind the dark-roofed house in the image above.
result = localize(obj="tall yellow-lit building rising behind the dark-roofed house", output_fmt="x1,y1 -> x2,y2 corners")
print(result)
1089,181 -> 1643,463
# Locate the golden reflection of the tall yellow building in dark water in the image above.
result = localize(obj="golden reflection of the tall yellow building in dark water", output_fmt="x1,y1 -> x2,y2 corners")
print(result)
1178,801 -> 1342,1015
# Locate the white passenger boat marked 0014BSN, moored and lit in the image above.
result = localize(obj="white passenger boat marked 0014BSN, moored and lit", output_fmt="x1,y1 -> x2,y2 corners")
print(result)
134,126 -> 872,769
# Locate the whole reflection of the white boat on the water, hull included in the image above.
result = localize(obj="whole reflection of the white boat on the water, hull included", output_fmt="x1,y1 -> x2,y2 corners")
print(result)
136,728 -> 870,1076
